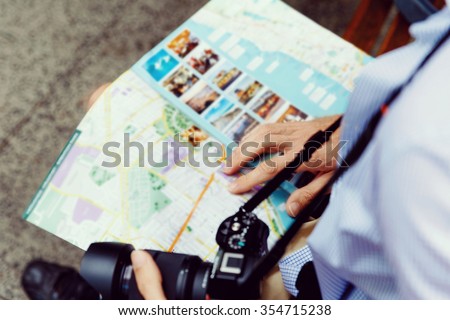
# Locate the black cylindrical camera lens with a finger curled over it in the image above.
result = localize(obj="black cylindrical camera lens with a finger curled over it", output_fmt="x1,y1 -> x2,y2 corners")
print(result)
80,242 -> 212,299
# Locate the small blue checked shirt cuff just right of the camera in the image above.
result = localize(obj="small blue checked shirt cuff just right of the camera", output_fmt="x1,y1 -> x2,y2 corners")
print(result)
278,245 -> 313,297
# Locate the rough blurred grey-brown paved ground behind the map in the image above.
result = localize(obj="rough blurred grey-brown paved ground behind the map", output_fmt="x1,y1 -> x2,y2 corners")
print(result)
0,0 -> 358,299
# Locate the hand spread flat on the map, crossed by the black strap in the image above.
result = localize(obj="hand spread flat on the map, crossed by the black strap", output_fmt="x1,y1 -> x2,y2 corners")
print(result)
224,116 -> 341,216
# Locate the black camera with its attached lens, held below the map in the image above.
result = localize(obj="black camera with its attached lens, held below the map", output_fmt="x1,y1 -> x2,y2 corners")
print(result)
80,207 -> 269,299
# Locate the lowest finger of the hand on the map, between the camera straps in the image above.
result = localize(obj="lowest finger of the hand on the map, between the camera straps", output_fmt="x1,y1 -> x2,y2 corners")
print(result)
286,171 -> 334,217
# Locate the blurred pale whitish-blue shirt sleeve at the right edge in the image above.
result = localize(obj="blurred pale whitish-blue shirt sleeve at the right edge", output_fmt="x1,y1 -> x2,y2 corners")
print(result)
374,36 -> 450,299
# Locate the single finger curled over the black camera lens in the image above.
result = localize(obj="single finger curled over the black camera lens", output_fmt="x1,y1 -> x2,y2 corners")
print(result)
131,250 -> 166,300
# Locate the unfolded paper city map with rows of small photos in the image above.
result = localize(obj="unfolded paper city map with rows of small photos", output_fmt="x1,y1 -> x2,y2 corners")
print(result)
24,0 -> 371,260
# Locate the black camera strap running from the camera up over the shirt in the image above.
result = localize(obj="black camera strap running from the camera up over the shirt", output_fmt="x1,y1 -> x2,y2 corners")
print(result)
241,29 -> 450,292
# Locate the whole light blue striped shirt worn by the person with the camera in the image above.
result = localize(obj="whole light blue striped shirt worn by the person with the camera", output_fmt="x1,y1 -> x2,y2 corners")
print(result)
279,3 -> 450,299
